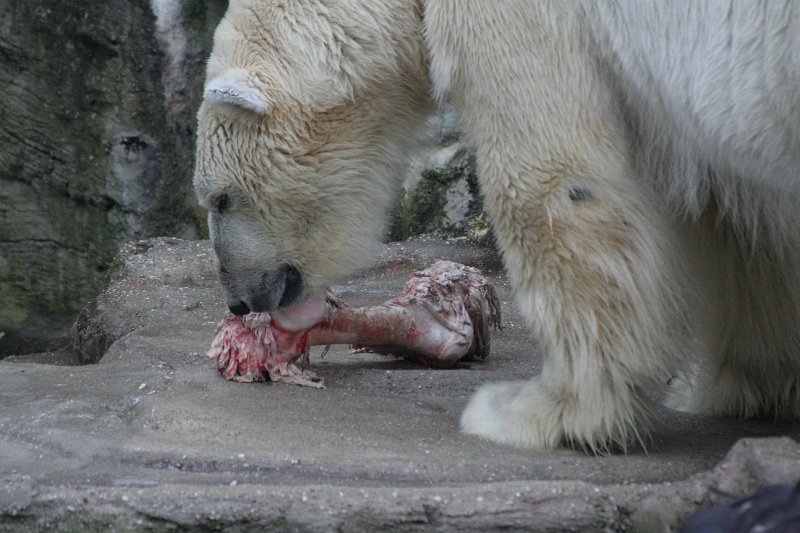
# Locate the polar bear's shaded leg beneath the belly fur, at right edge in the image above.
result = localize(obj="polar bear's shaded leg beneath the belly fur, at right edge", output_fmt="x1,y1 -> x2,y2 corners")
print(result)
667,208 -> 800,419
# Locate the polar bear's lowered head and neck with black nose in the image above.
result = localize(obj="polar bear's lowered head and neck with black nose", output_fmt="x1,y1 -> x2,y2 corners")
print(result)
194,0 -> 431,314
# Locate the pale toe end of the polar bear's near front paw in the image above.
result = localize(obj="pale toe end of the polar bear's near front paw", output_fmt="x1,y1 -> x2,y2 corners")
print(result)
461,382 -> 564,449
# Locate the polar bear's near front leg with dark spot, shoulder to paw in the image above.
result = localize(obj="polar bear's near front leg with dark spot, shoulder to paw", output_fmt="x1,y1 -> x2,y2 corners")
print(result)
425,0 -> 691,452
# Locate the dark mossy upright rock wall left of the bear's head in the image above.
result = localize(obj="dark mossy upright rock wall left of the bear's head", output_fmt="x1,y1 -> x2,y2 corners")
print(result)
0,0 -> 227,357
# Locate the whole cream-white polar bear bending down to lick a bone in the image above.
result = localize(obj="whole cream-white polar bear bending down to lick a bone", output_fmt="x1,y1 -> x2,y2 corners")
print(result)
194,0 -> 800,453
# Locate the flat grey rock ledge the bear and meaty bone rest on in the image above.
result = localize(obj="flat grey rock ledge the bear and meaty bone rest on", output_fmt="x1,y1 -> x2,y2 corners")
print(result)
0,238 -> 800,531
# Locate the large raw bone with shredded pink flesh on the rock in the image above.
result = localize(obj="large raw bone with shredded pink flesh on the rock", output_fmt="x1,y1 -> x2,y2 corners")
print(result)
209,261 -> 500,387
